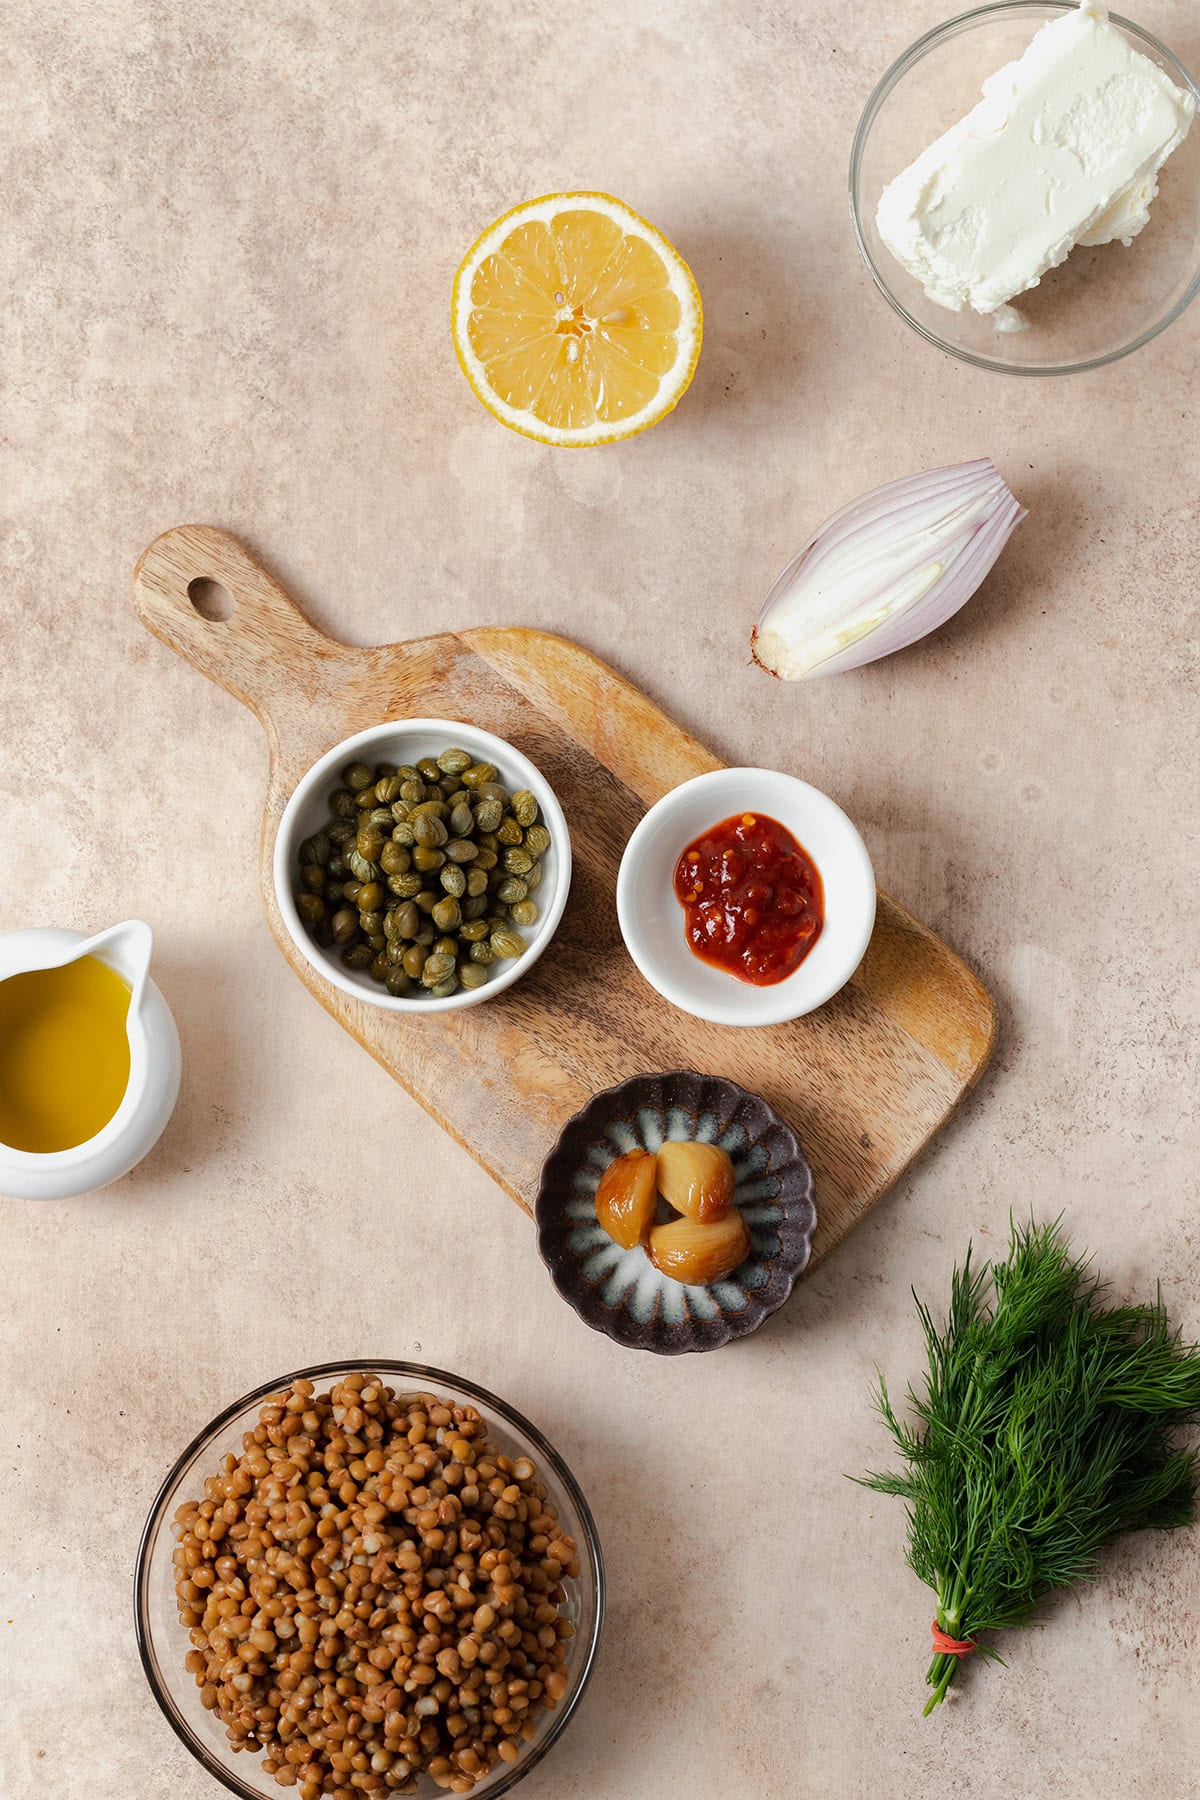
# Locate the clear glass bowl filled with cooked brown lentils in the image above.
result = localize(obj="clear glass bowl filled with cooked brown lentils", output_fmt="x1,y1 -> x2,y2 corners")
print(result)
135,1361 -> 604,1800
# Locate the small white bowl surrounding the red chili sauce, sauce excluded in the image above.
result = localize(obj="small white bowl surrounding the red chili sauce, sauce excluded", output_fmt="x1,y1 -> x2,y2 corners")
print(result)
617,769 -> 874,1026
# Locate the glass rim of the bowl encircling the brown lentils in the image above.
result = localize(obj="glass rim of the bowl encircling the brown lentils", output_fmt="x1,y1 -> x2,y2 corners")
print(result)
133,1357 -> 604,1800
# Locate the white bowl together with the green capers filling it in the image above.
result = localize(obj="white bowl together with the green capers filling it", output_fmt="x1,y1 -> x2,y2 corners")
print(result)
273,718 -> 570,1012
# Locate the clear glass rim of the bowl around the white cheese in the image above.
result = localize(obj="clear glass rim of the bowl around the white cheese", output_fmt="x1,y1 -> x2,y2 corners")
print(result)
849,0 -> 1200,376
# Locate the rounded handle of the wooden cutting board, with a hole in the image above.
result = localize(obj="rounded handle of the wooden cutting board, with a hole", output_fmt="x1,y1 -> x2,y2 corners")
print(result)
133,526 -> 345,729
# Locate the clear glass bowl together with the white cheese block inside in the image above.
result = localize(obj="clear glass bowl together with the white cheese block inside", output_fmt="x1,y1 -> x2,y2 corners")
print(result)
851,0 -> 1200,374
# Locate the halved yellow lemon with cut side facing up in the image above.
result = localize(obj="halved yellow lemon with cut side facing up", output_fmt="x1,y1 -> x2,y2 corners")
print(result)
450,194 -> 702,445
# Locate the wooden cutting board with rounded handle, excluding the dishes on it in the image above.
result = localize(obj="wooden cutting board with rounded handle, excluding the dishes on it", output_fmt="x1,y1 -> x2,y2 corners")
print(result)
133,526 -> 995,1262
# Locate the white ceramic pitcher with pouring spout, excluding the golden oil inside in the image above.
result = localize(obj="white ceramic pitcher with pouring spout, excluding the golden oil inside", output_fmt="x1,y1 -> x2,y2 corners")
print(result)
0,918 -> 180,1201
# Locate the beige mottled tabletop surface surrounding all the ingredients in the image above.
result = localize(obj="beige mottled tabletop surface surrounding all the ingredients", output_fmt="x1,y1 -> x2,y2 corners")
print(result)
0,0 -> 1200,1800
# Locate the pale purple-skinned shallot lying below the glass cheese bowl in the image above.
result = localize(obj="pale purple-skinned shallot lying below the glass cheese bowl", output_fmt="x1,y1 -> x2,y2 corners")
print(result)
750,457 -> 1025,680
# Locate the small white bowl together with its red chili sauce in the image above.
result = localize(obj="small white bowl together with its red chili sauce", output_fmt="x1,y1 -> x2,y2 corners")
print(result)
617,769 -> 874,1026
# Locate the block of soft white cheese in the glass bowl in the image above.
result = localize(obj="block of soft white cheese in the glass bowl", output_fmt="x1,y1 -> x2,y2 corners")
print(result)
876,0 -> 1196,313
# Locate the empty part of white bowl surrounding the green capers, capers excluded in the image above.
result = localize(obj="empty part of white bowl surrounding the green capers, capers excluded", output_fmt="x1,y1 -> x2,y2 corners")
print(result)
273,718 -> 570,1013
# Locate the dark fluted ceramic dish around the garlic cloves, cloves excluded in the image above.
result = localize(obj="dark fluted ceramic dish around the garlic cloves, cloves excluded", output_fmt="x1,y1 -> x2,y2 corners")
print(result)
534,1069 -> 817,1355
